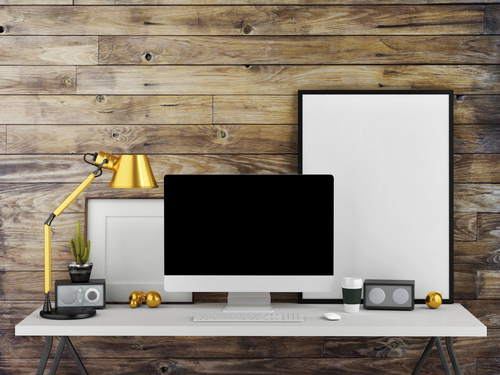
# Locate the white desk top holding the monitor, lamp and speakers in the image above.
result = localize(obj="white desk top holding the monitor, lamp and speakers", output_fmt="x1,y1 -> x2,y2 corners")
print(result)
16,303 -> 486,337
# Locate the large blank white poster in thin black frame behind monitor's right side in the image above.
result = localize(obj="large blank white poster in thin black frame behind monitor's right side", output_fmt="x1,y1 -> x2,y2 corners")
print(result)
299,90 -> 453,303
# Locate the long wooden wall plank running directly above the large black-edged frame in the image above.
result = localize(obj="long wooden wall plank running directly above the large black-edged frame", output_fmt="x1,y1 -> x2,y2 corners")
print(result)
78,65 -> 500,95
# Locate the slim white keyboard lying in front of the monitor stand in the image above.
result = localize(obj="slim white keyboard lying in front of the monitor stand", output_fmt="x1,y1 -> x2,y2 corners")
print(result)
193,313 -> 304,322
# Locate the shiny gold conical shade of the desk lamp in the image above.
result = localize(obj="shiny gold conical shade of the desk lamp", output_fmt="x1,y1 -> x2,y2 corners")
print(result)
108,155 -> 158,189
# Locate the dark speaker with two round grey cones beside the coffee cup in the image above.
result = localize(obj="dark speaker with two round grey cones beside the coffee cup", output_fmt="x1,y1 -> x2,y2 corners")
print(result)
363,280 -> 415,310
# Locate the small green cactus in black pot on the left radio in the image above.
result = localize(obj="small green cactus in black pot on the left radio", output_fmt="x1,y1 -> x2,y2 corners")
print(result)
68,220 -> 92,283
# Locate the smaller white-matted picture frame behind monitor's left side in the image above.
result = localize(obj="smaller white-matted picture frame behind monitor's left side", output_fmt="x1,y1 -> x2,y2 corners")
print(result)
85,198 -> 192,303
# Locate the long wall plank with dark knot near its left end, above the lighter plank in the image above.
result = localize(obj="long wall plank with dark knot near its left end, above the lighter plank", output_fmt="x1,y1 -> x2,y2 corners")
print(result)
99,36 -> 500,65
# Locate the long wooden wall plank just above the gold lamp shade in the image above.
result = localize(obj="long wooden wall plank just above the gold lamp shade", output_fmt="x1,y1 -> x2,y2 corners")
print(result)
7,125 -> 298,155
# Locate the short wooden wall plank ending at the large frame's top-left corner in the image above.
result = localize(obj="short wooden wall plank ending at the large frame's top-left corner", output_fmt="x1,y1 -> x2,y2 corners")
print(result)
213,95 -> 298,124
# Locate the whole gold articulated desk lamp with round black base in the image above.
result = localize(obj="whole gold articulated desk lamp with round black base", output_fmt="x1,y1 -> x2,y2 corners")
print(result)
40,152 -> 158,319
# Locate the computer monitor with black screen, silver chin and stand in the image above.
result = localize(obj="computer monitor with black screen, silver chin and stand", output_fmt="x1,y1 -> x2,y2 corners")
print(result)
164,174 -> 334,311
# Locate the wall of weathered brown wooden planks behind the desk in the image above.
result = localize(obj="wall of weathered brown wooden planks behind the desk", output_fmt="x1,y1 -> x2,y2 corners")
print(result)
0,0 -> 500,375
